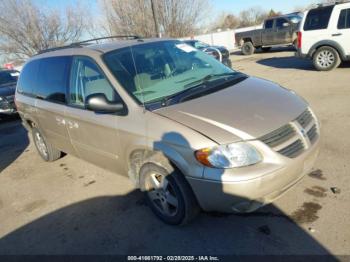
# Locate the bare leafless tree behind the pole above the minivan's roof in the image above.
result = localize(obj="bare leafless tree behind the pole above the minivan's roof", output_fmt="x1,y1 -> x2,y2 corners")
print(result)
101,0 -> 208,37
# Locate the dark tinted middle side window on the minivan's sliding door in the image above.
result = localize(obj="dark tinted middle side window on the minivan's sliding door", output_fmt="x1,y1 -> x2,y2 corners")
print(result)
35,56 -> 71,103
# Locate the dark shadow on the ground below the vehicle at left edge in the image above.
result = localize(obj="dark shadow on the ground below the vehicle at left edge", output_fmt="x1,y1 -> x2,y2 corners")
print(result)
0,117 -> 29,173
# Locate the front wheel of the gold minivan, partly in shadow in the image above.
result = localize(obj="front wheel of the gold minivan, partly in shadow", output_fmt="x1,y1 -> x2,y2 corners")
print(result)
140,163 -> 200,225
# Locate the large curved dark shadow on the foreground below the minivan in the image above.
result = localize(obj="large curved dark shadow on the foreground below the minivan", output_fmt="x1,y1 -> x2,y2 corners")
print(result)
0,191 -> 334,255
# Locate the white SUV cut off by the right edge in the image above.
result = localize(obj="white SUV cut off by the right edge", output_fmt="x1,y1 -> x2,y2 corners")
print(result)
296,2 -> 350,71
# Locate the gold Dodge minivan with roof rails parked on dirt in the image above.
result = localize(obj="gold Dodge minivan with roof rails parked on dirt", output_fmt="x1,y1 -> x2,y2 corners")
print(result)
16,37 -> 320,225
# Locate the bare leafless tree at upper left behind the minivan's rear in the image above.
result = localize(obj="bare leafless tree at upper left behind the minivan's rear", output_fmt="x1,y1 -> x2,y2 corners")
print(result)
0,0 -> 86,58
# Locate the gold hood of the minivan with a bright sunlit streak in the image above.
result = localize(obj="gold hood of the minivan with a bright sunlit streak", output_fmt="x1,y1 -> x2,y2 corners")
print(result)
153,77 -> 307,144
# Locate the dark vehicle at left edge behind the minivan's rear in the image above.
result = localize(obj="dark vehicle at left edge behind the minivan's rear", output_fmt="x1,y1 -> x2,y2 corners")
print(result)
0,69 -> 19,116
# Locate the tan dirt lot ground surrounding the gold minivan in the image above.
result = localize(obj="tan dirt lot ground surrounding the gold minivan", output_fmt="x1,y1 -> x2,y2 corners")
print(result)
0,50 -> 350,255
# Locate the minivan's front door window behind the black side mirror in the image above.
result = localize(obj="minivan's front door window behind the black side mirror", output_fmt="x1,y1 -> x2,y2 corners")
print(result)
69,57 -> 117,107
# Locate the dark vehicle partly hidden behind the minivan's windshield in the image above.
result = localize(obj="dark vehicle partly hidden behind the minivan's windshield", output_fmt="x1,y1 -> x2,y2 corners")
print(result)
184,40 -> 232,67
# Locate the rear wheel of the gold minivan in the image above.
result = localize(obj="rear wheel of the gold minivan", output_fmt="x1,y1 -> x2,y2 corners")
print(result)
32,127 -> 62,162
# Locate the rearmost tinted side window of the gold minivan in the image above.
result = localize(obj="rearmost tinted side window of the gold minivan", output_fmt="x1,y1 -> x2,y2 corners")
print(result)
17,60 -> 40,96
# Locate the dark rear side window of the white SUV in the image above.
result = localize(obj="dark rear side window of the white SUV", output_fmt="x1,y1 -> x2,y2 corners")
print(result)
304,6 -> 334,31
